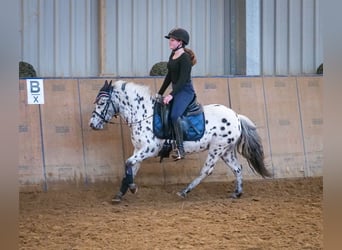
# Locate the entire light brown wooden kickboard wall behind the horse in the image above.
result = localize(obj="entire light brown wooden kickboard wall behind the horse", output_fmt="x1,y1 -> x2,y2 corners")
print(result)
18,76 -> 323,190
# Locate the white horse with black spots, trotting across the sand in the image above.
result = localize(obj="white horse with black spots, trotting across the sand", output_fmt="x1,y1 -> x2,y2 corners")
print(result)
89,80 -> 271,202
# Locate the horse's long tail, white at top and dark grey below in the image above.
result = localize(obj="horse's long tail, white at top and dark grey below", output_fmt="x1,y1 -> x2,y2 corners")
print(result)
237,115 -> 272,178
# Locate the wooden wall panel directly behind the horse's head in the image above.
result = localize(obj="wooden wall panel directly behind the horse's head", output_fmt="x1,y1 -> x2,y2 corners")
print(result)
79,79 -> 124,182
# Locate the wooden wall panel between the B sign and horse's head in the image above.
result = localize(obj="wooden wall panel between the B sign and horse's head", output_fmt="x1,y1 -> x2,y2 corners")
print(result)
41,79 -> 85,187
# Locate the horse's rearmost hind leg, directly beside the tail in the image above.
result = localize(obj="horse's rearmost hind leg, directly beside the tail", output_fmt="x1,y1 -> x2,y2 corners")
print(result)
221,150 -> 243,198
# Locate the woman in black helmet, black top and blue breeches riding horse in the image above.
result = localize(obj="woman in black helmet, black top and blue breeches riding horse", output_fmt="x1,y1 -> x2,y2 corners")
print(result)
158,28 -> 196,161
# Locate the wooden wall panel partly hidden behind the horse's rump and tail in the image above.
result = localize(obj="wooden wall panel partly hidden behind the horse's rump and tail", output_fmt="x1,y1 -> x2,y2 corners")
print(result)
229,77 -> 273,179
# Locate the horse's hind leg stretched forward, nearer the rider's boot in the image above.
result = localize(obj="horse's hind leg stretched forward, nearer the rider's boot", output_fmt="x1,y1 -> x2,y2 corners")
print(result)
177,152 -> 219,198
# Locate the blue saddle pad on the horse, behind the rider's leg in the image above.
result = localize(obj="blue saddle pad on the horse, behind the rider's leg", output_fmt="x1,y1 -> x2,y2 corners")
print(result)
153,96 -> 205,141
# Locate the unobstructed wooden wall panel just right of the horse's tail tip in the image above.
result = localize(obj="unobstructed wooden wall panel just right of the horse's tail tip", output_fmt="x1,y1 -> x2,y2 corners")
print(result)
264,77 -> 305,178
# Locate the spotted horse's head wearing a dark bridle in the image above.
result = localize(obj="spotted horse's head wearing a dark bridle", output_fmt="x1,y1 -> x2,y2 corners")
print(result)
89,80 -> 118,130
